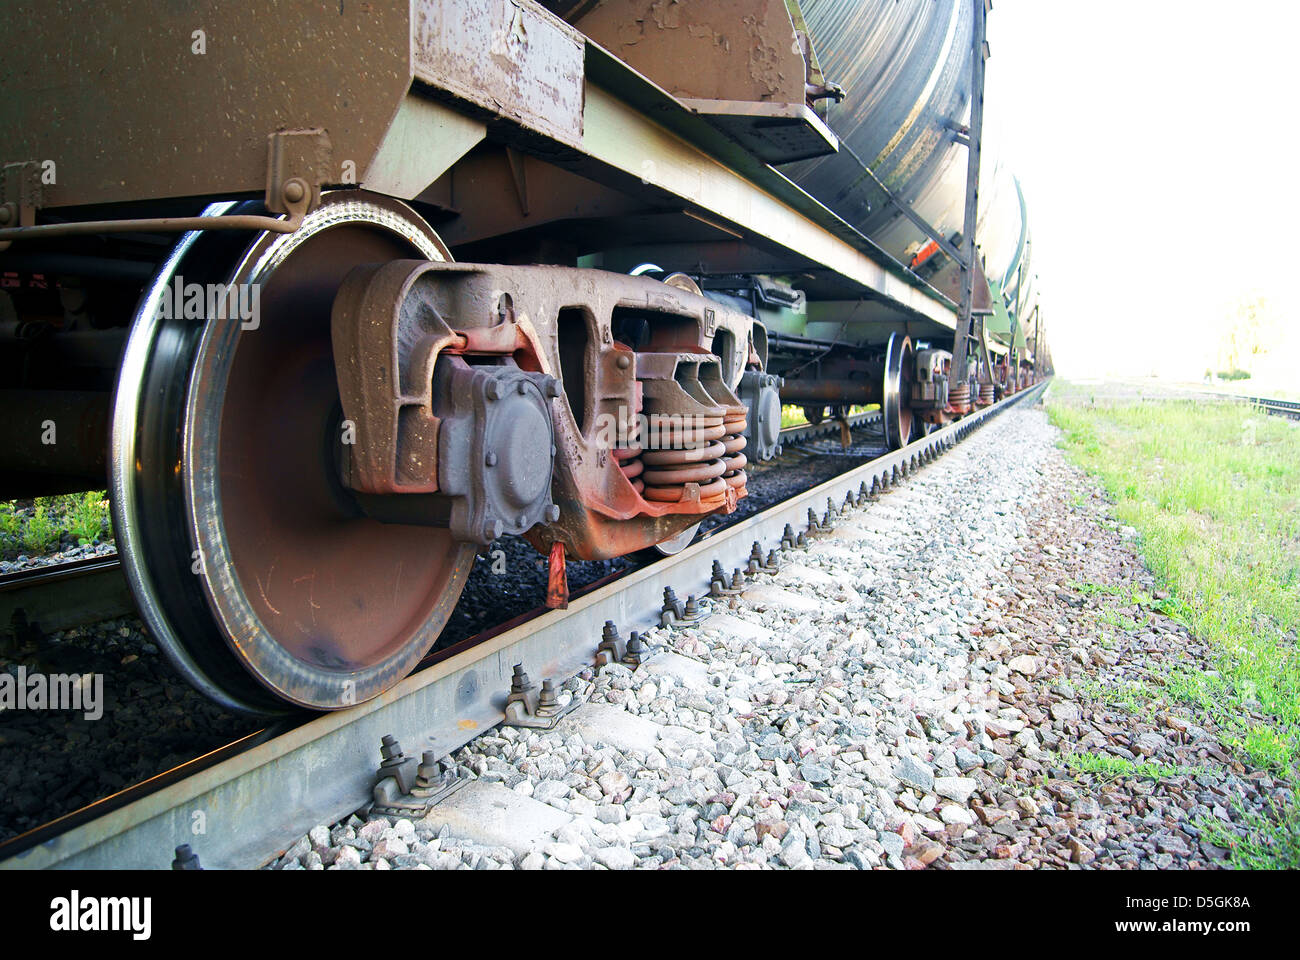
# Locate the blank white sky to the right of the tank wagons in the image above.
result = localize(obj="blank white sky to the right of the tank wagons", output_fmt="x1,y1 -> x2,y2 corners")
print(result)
985,0 -> 1300,379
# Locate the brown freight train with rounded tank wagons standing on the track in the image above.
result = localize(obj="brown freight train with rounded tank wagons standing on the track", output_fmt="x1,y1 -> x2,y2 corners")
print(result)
0,0 -> 1050,714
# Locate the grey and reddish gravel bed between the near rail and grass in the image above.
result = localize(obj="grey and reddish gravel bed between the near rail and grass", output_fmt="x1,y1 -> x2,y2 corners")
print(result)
273,405 -> 1282,869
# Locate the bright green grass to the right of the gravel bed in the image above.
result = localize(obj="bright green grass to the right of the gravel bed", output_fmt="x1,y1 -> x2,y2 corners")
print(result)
1047,384 -> 1300,866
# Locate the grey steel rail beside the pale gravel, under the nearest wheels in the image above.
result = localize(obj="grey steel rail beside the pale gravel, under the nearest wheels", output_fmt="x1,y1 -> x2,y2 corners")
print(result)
0,384 -> 1045,869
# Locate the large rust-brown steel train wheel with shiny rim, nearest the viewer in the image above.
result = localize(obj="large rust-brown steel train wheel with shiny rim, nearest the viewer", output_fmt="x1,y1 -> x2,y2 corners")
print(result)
113,191 -> 475,713
